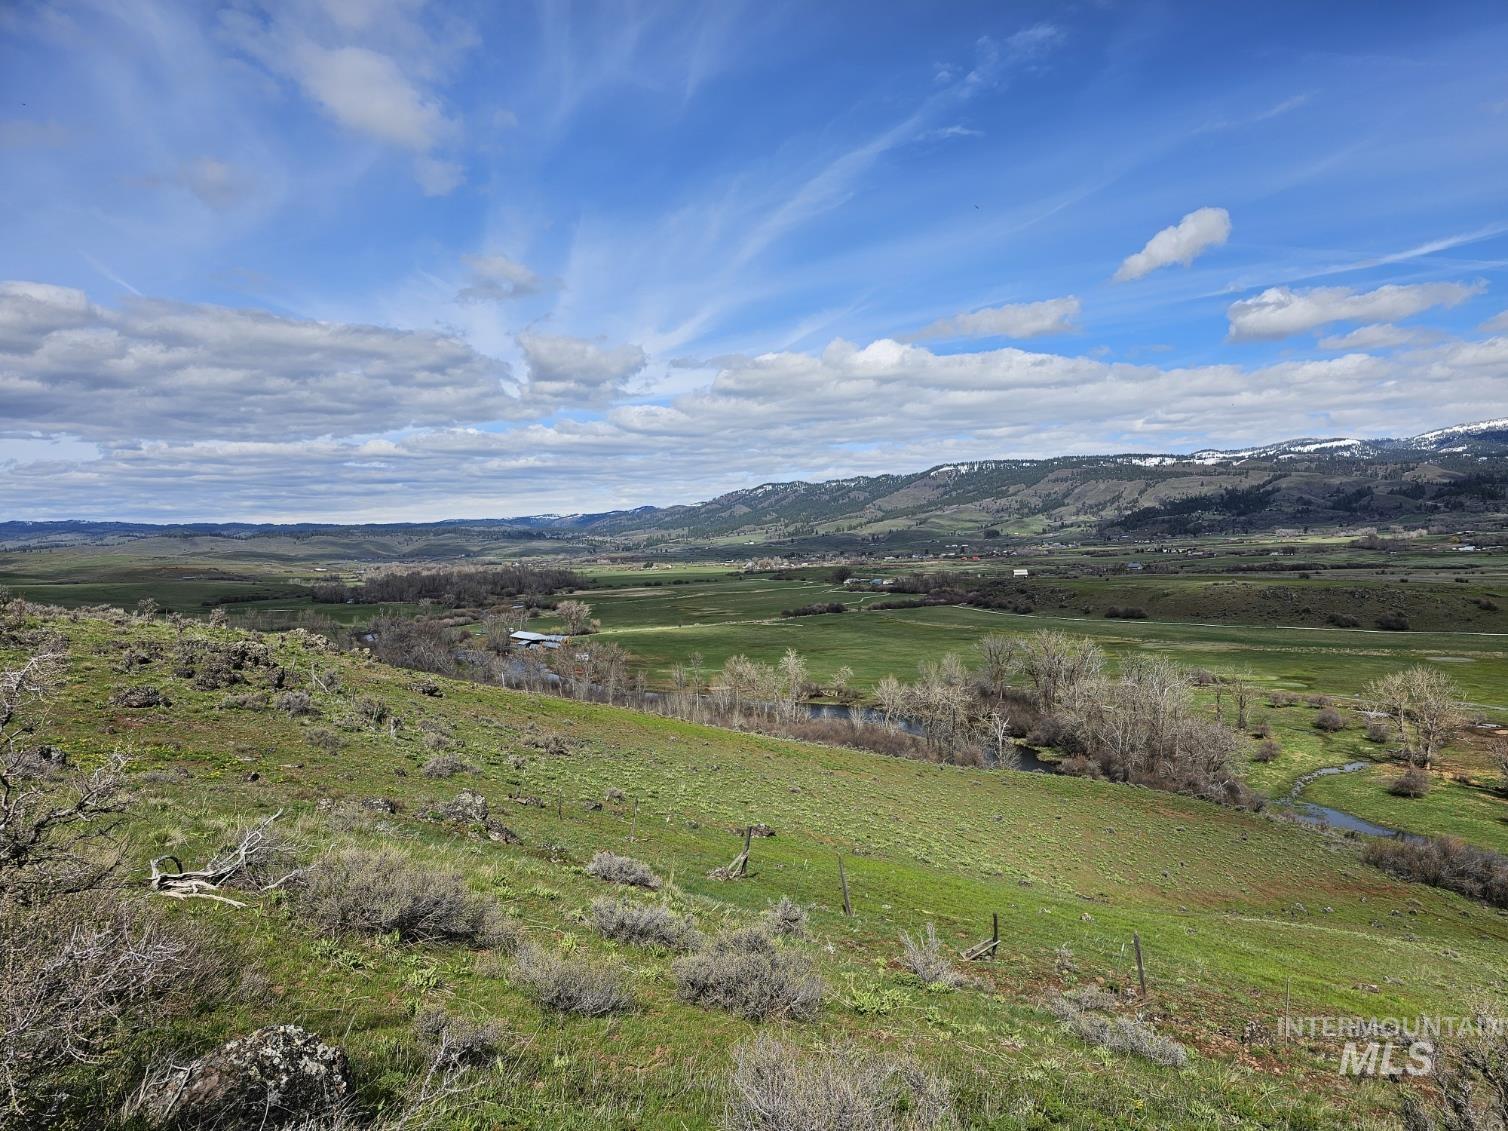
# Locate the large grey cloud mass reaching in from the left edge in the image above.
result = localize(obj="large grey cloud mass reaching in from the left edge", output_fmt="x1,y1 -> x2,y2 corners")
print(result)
0,282 -> 519,443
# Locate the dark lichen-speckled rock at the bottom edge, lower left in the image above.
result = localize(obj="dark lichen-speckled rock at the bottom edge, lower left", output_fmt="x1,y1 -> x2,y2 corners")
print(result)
133,1025 -> 353,1131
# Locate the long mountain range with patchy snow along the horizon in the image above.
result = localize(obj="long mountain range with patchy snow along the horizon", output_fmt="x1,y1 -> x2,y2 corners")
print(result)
0,418 -> 1508,549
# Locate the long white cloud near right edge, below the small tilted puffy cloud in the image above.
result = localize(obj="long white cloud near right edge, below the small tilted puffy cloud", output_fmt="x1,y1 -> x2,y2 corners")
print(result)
1226,282 -> 1487,341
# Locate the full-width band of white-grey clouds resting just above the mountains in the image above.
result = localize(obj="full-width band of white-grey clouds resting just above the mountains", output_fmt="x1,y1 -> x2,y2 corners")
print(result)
0,284 -> 1508,520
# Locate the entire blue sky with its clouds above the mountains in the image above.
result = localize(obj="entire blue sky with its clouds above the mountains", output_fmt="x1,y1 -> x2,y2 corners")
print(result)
0,0 -> 1508,522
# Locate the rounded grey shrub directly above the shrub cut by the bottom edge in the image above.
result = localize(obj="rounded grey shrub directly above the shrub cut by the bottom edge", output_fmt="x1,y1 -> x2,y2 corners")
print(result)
671,929 -> 823,1021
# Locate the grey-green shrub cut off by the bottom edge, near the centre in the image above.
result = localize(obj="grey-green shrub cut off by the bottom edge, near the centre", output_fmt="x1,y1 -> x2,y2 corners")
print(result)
722,1033 -> 955,1131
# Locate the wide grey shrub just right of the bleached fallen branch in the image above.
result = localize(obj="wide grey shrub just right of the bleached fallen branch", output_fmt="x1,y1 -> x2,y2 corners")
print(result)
294,849 -> 522,950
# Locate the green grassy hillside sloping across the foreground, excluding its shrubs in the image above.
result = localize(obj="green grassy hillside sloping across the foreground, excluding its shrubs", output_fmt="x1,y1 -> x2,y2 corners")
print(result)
11,612 -> 1508,1128
